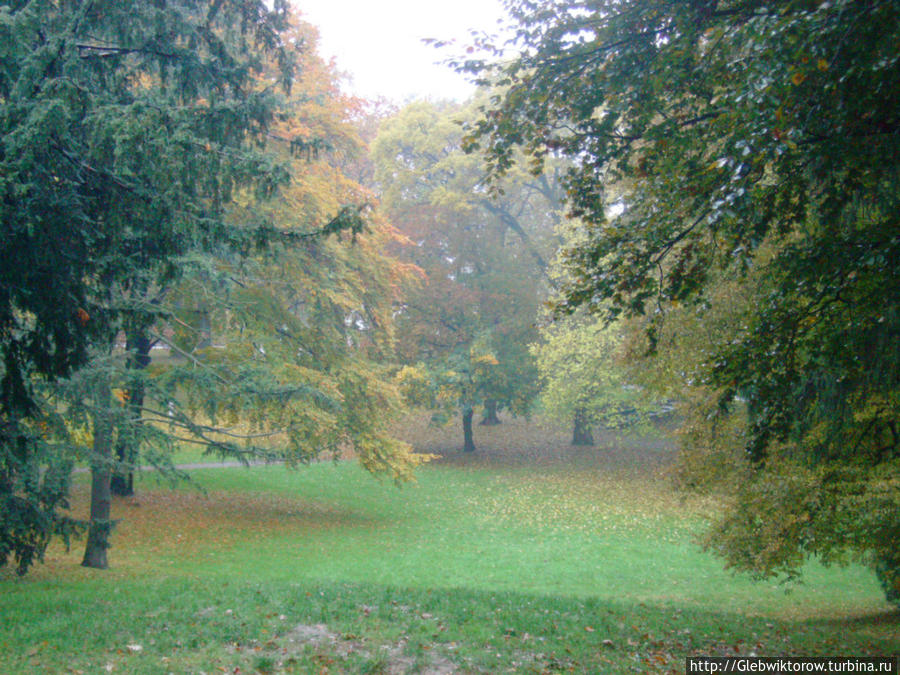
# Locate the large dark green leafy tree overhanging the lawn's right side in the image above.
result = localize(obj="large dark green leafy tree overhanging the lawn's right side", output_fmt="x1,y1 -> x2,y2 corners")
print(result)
463,0 -> 900,604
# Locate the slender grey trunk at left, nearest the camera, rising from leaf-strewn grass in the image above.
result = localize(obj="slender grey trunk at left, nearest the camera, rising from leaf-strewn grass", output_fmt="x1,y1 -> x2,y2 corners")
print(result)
81,380 -> 112,570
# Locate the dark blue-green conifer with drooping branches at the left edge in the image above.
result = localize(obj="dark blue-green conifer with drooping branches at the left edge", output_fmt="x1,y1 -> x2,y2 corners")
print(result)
0,1 -> 292,569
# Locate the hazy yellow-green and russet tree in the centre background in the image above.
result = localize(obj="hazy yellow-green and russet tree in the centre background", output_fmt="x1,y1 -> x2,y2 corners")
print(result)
373,103 -> 561,450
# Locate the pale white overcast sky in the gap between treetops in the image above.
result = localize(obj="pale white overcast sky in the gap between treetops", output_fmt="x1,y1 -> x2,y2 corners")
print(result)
293,0 -> 504,103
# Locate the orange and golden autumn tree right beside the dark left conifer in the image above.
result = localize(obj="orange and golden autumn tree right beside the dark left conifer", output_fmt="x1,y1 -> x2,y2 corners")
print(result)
209,17 -> 423,482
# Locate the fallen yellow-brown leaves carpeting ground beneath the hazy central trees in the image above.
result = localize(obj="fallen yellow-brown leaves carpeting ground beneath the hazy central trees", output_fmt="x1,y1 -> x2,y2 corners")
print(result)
404,415 -> 715,542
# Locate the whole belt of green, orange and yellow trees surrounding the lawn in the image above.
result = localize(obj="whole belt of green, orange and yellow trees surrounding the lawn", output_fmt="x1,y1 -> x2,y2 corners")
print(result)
0,0 -> 900,672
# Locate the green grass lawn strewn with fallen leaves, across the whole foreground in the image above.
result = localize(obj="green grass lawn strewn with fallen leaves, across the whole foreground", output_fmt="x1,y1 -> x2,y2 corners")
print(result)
0,420 -> 900,673
